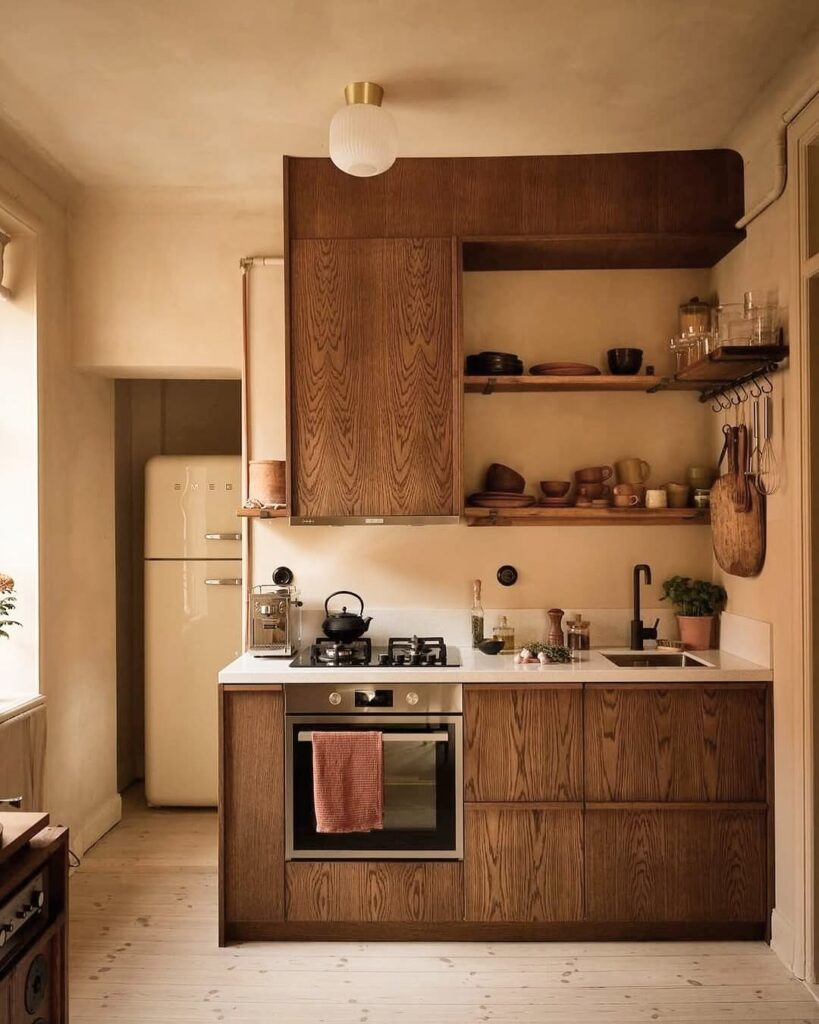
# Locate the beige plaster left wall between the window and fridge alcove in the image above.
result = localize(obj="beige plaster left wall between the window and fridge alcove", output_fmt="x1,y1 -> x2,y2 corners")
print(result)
0,131 -> 120,852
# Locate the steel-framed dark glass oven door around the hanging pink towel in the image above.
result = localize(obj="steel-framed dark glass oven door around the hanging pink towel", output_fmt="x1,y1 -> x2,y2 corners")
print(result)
290,723 -> 457,853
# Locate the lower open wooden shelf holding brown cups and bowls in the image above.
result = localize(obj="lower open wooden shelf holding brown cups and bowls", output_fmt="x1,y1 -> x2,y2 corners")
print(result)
464,505 -> 710,526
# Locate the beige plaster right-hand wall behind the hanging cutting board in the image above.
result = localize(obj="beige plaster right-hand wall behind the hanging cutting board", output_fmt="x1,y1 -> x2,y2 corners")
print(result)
713,37 -> 819,977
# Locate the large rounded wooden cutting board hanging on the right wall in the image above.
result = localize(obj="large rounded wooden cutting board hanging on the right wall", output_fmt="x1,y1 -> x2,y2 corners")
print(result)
710,473 -> 765,577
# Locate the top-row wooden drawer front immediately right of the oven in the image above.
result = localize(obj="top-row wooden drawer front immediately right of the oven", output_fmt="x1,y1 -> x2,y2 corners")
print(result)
464,687 -> 583,802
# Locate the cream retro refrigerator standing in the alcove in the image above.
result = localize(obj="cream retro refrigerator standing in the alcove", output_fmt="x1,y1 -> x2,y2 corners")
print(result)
144,456 -> 244,807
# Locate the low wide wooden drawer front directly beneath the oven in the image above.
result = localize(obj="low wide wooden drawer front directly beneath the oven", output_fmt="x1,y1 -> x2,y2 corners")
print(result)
286,861 -> 464,922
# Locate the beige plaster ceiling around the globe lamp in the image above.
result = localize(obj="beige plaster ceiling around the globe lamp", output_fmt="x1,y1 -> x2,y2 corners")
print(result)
0,0 -> 819,189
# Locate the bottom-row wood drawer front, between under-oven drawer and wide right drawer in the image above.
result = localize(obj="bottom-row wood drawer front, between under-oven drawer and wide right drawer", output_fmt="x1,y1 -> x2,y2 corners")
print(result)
464,804 -> 584,922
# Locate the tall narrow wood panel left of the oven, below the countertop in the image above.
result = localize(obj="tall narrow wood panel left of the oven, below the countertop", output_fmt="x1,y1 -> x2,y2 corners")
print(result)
219,686 -> 285,942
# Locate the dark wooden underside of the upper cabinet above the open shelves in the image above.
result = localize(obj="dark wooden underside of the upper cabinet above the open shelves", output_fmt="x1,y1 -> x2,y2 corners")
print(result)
462,230 -> 745,271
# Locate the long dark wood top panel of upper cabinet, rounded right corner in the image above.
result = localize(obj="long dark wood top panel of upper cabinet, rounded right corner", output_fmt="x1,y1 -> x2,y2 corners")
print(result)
286,150 -> 744,242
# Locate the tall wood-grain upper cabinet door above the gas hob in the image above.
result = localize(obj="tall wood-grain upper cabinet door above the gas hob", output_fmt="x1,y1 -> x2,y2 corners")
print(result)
289,239 -> 461,517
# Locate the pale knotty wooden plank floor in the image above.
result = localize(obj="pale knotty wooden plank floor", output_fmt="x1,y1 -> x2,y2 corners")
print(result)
70,793 -> 819,1024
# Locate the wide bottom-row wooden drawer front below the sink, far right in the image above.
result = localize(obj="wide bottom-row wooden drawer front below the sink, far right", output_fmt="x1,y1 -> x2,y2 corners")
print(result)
586,807 -> 767,922
